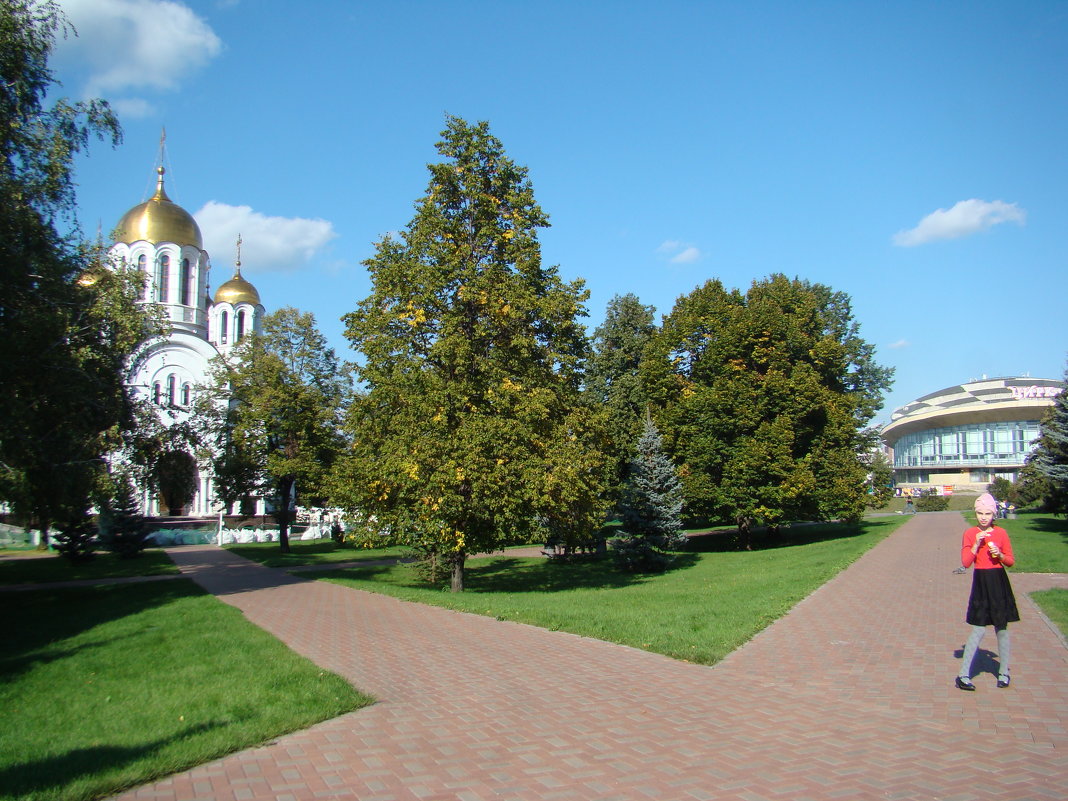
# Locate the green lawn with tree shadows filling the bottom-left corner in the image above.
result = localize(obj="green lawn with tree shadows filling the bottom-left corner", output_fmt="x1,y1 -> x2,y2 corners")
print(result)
0,580 -> 370,801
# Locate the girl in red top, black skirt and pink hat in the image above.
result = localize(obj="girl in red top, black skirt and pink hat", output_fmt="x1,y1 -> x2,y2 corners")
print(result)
957,492 -> 1020,692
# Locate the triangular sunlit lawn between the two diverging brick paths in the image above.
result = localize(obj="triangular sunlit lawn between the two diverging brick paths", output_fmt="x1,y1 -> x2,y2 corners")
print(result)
304,517 -> 906,664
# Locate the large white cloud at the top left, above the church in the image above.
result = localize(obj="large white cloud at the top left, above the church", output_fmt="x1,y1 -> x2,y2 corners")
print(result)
59,0 -> 222,99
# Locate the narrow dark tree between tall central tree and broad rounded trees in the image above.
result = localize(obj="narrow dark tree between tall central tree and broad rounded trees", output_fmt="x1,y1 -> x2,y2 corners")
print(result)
585,295 -> 657,508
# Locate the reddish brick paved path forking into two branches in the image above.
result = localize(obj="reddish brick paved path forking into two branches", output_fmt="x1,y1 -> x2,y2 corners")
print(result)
112,513 -> 1068,801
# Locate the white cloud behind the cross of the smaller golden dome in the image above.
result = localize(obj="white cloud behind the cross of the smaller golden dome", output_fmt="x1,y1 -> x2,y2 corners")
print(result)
193,201 -> 337,272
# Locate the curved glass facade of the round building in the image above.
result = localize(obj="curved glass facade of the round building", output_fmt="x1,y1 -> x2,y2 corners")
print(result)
894,420 -> 1038,470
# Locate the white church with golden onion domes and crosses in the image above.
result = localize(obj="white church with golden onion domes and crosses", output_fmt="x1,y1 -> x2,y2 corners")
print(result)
109,167 -> 265,517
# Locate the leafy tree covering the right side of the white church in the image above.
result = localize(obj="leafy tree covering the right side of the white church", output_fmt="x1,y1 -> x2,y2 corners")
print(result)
198,307 -> 349,553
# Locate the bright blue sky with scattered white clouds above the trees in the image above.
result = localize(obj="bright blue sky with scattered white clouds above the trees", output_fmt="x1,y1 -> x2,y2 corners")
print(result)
52,0 -> 1068,422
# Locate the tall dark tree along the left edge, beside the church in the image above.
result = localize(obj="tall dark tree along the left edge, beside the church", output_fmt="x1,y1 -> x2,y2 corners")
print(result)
0,0 -> 137,543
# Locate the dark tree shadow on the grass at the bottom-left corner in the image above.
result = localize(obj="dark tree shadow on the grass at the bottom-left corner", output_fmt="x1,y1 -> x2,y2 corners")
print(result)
0,722 -> 225,798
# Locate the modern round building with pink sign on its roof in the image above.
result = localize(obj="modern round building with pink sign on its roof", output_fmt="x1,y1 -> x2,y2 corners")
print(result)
882,376 -> 1065,491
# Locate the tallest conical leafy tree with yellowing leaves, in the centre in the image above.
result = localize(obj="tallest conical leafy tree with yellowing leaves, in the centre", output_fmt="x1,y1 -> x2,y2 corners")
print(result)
344,117 -> 604,591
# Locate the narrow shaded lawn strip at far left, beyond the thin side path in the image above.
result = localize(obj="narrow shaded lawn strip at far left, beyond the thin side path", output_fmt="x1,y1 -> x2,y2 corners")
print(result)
0,548 -> 178,585
